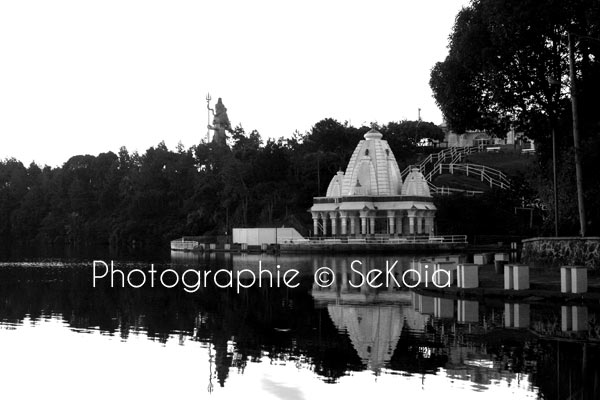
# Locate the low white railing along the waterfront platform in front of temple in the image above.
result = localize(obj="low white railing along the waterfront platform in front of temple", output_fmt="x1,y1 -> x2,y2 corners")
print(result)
280,235 -> 467,246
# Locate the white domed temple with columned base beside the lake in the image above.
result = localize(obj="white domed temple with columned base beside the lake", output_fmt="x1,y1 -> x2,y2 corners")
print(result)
310,129 -> 436,237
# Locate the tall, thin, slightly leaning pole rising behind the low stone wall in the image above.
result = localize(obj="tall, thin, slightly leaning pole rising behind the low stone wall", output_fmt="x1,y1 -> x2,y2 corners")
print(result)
568,32 -> 586,236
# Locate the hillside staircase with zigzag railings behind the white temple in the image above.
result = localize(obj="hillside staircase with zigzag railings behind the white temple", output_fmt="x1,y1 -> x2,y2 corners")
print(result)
400,145 -> 510,195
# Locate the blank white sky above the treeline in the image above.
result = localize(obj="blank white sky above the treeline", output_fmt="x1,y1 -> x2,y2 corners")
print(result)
0,0 -> 468,166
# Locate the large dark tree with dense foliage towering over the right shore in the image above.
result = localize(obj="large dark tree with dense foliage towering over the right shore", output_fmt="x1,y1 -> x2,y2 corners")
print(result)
430,0 -> 600,235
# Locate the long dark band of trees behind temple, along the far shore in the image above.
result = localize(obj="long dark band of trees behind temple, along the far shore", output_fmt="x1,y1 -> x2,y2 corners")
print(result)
0,119 -> 443,245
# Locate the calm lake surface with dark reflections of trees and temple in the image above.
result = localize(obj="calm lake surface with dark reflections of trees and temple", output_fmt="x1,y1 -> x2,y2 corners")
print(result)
0,254 -> 600,399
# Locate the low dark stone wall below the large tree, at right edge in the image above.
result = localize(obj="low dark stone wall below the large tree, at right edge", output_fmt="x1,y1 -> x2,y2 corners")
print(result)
521,236 -> 600,269
